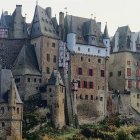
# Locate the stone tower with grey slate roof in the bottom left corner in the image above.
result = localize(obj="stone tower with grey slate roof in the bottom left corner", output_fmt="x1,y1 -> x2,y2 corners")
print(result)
0,69 -> 23,140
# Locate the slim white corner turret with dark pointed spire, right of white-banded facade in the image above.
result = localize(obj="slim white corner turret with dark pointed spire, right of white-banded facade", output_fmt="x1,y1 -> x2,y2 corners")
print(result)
103,24 -> 110,56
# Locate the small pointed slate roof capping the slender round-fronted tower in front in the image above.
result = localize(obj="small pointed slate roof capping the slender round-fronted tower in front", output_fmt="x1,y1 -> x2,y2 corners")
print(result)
48,70 -> 64,86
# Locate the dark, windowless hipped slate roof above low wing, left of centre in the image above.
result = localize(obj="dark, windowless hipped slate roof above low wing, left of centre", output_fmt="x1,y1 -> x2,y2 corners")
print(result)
12,44 -> 41,75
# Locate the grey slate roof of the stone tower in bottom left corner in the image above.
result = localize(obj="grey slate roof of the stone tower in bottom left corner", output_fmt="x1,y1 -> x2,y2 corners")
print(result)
0,69 -> 22,103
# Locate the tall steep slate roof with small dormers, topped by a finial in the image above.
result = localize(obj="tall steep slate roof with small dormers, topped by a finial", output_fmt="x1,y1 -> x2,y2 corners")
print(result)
31,5 -> 59,39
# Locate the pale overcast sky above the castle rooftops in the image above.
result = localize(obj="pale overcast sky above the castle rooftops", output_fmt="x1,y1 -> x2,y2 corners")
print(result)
0,0 -> 140,36
